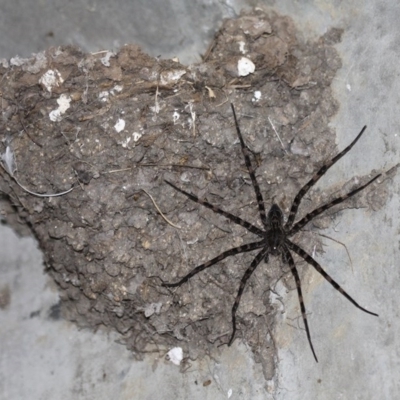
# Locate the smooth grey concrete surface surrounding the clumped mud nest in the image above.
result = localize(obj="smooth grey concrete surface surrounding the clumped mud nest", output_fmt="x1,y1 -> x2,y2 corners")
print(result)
0,0 -> 400,400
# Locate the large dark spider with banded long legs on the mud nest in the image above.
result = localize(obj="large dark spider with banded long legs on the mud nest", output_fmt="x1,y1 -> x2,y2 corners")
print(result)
162,104 -> 381,362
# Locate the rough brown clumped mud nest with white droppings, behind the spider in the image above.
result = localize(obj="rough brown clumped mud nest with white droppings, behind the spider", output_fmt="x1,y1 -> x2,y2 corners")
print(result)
0,10 -> 386,379
